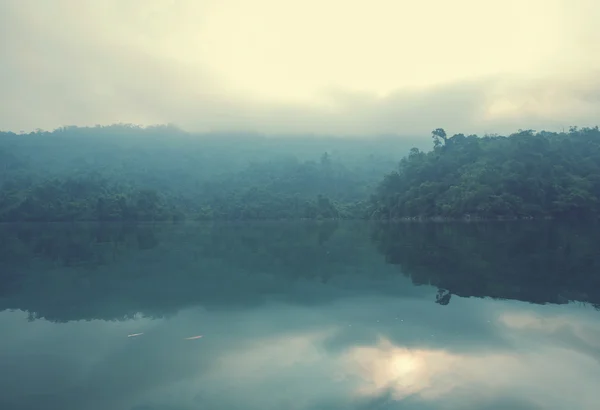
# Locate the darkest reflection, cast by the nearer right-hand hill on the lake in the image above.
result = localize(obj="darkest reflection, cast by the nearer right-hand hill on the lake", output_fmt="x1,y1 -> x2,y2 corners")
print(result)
372,222 -> 600,305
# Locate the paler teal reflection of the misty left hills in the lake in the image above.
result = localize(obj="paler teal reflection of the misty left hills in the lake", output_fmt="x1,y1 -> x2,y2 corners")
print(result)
0,221 -> 379,321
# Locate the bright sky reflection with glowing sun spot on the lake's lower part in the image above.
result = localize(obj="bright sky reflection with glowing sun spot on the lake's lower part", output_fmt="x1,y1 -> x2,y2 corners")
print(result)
0,298 -> 600,409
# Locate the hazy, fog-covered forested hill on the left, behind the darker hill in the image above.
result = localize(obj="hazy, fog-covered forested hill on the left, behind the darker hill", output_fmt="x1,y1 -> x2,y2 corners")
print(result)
0,124 -> 428,221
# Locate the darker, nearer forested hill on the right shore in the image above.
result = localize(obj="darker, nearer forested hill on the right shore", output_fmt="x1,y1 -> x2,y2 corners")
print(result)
371,127 -> 600,219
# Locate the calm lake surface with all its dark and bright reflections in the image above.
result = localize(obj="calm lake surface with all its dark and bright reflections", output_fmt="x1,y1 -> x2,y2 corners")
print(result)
0,223 -> 600,410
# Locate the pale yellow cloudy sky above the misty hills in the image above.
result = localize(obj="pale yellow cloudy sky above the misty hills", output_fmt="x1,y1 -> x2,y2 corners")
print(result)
0,0 -> 600,136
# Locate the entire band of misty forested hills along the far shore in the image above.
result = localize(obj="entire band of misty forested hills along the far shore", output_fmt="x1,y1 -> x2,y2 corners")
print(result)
0,124 -> 600,222
